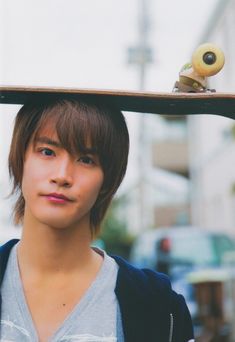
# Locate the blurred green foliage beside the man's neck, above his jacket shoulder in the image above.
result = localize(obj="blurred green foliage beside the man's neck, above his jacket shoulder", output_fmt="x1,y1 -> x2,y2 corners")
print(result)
100,199 -> 133,258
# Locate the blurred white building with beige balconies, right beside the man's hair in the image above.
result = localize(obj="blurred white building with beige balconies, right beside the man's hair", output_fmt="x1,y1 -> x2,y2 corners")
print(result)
118,114 -> 191,234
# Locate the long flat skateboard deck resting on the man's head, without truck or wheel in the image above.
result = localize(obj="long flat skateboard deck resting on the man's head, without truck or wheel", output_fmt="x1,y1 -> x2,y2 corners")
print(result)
0,86 -> 235,119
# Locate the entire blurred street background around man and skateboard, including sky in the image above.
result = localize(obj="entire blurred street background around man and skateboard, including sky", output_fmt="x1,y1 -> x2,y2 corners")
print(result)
0,0 -> 235,342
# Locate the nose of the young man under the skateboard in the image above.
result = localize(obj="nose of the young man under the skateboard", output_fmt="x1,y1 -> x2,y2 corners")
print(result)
51,159 -> 73,187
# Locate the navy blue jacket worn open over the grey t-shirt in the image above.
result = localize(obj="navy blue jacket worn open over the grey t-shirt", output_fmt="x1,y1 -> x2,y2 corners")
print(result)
0,240 -> 193,342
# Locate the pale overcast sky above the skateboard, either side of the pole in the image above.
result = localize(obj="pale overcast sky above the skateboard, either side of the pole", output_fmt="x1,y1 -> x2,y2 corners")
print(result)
0,0 -> 218,91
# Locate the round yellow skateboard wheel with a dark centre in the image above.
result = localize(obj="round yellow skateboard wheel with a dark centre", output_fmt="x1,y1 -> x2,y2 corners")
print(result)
192,43 -> 225,77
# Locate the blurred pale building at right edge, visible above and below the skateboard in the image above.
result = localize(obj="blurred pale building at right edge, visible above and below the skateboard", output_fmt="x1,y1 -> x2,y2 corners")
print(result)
189,0 -> 235,234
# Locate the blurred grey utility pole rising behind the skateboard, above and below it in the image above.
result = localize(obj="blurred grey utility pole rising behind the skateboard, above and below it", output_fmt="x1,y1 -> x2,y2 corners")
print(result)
128,0 -> 153,230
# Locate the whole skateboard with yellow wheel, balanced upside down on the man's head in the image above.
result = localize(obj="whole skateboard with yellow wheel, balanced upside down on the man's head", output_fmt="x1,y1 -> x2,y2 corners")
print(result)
0,44 -> 235,119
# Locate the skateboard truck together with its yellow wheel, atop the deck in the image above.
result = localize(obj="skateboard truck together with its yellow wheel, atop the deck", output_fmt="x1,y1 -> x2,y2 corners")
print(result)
173,43 -> 224,93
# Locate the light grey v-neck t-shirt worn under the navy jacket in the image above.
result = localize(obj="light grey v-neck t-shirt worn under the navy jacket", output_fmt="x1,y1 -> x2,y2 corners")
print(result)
0,245 -> 124,342
